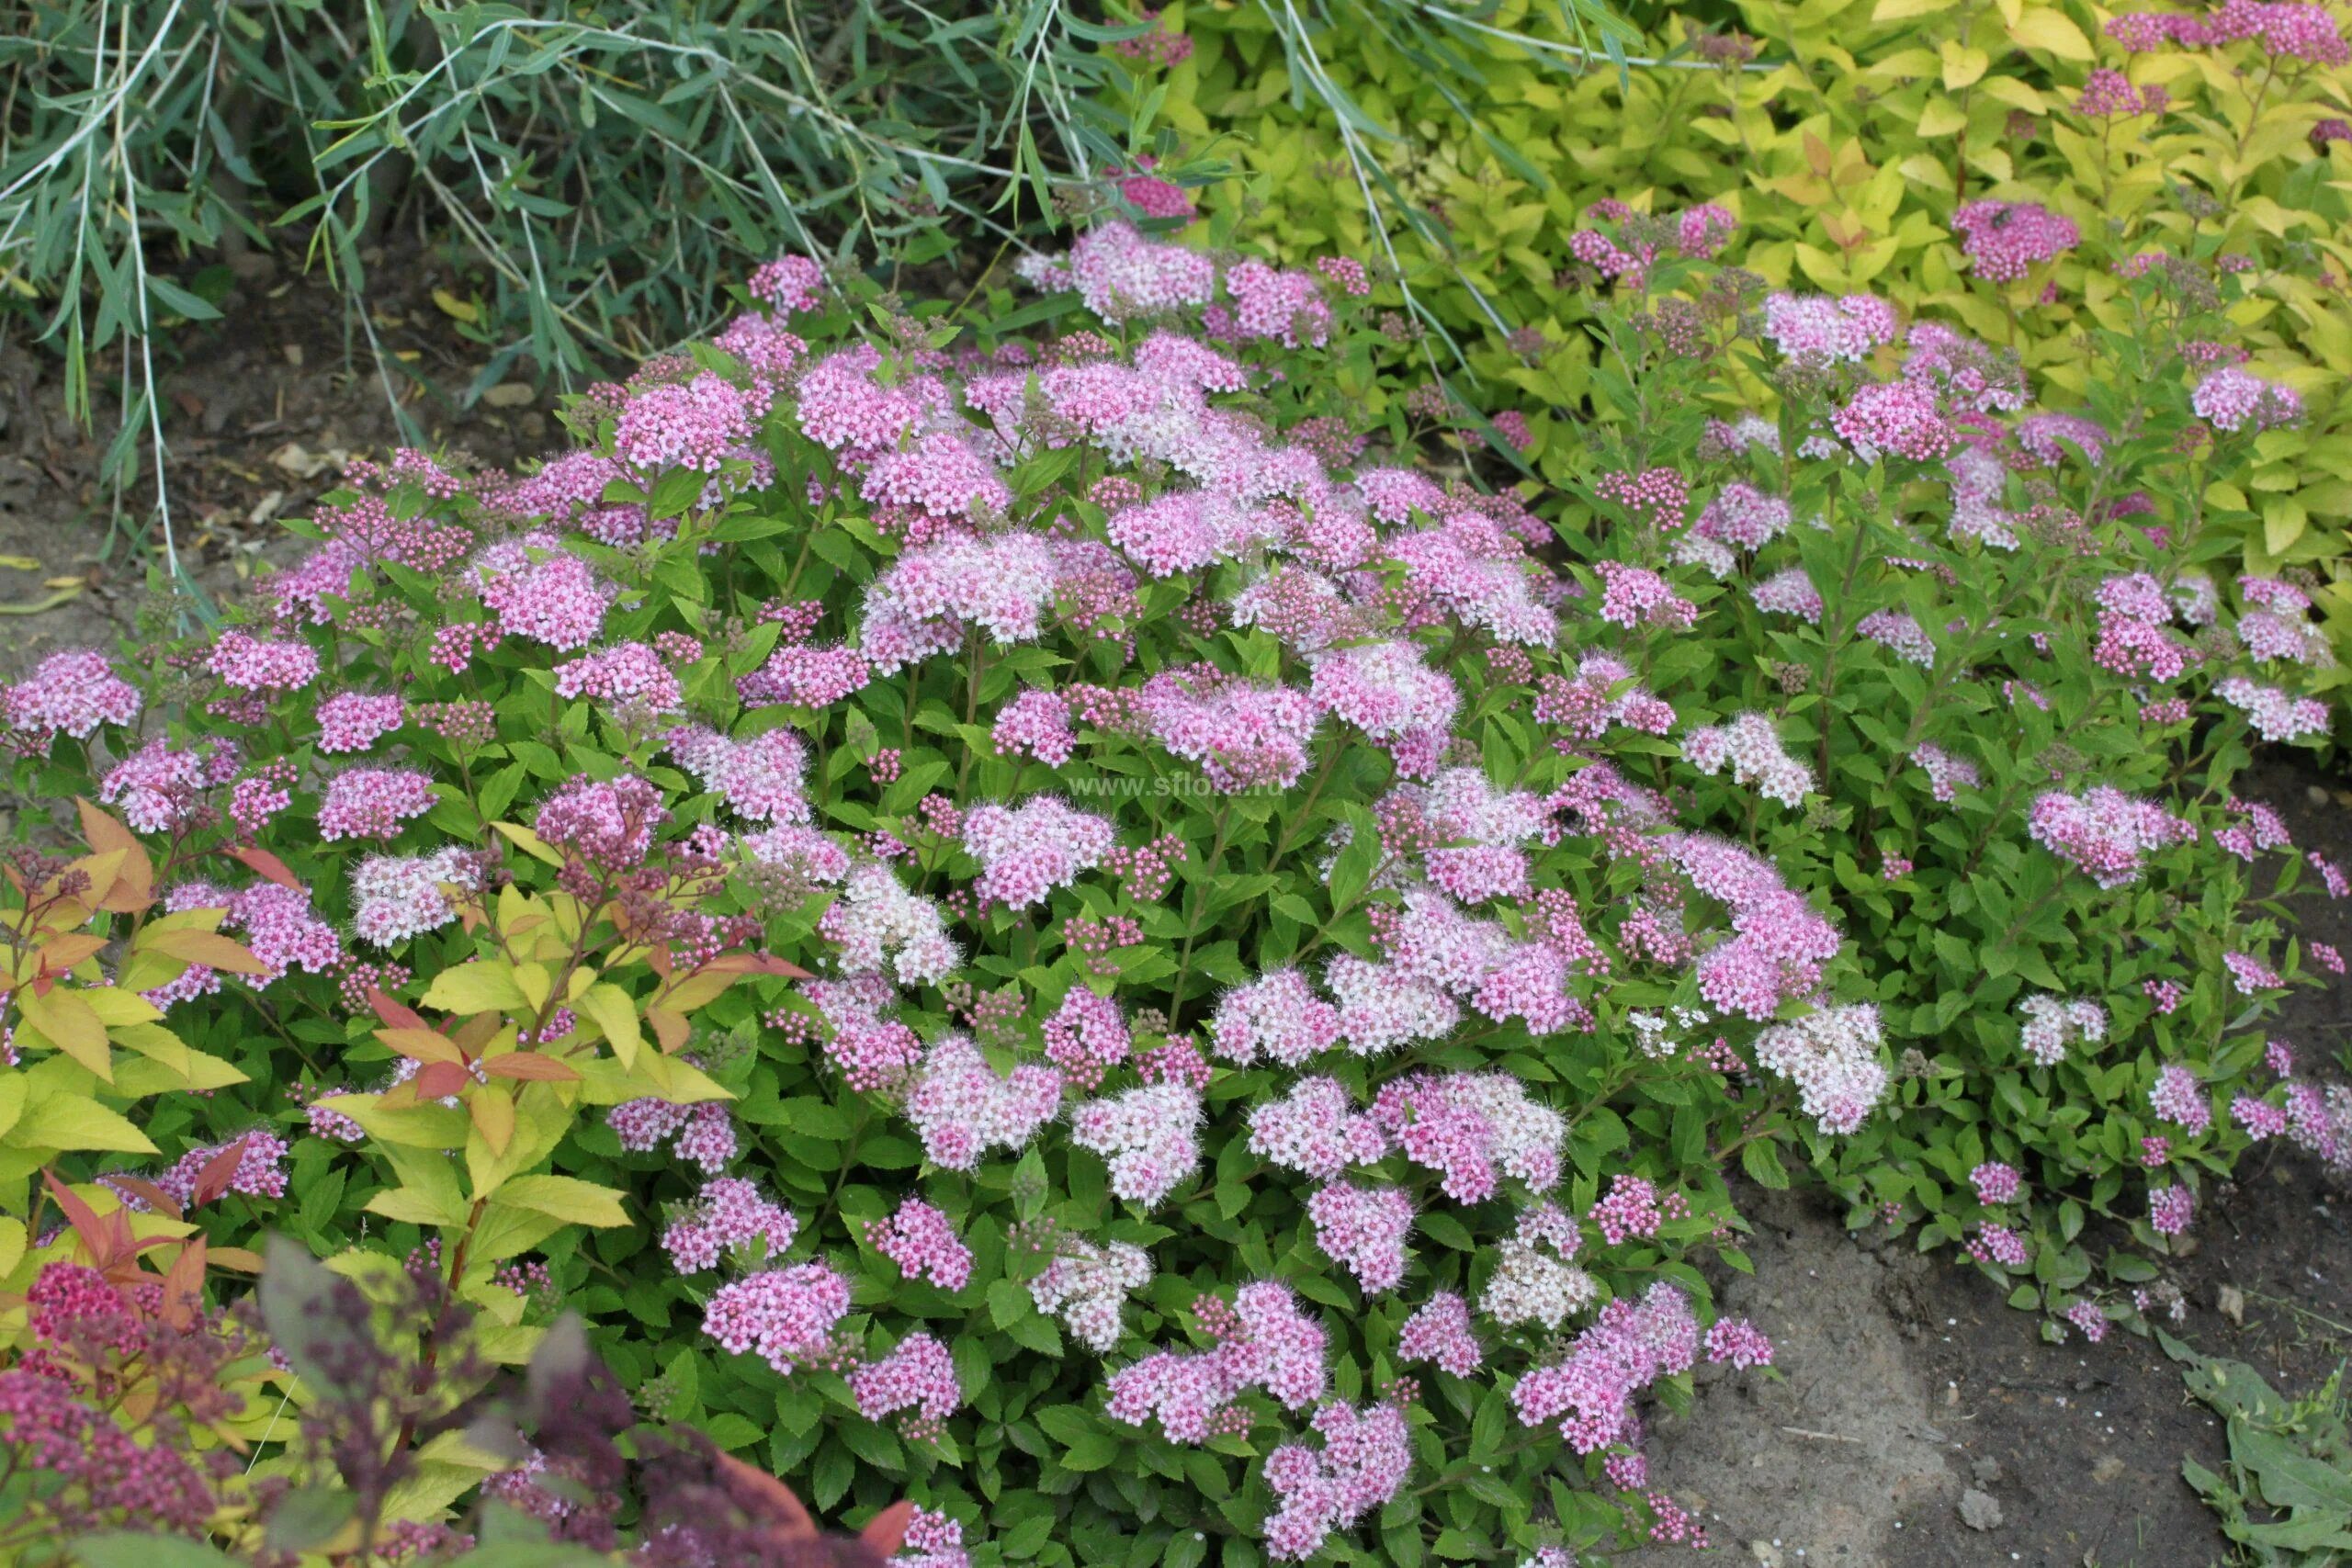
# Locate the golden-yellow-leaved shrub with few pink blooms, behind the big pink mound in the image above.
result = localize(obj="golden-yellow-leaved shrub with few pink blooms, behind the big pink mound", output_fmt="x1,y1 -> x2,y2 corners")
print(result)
1131,0 -> 2352,689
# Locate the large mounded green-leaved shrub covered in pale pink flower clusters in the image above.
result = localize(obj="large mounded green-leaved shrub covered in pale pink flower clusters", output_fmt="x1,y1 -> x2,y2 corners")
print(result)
5,211 -> 2352,1568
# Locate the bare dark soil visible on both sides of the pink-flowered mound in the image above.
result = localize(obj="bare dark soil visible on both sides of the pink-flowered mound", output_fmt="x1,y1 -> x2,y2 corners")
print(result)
0,256 -> 2352,1568
